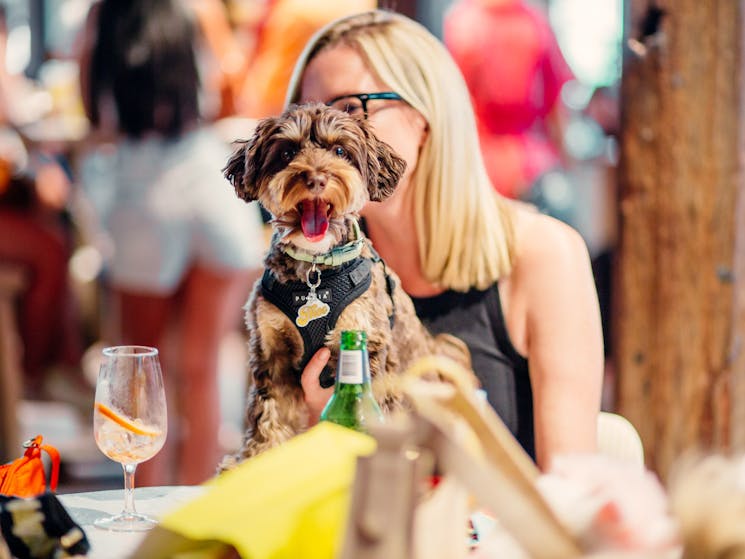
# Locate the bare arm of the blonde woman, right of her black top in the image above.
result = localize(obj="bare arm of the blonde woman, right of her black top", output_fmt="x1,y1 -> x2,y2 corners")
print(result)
506,214 -> 603,469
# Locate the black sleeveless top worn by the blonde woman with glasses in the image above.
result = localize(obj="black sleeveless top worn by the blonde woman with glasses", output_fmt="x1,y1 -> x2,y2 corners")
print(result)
411,283 -> 535,460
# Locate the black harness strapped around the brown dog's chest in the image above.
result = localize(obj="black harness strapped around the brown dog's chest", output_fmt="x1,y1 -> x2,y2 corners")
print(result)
261,252 -> 396,372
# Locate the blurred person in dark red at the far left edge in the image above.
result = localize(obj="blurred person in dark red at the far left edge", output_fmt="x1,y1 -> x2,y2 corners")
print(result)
0,6 -> 88,411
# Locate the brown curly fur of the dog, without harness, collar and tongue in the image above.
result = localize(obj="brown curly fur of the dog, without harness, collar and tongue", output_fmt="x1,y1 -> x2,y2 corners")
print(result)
221,104 -> 470,469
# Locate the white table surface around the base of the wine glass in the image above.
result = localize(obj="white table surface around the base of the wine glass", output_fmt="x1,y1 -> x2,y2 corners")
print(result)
57,486 -> 205,559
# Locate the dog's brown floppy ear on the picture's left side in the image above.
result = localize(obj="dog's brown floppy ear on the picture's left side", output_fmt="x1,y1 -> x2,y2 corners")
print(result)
223,118 -> 276,202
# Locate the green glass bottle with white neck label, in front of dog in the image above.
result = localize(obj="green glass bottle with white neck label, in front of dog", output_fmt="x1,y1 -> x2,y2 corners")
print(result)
321,330 -> 383,432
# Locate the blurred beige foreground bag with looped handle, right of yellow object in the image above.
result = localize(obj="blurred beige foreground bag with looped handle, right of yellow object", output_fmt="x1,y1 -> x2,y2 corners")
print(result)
341,357 -> 580,559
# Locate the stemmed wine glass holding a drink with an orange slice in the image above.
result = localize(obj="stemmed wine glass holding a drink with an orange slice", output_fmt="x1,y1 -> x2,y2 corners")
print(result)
93,345 -> 168,532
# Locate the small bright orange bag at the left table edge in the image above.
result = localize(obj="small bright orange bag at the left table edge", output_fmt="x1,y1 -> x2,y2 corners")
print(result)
0,435 -> 60,497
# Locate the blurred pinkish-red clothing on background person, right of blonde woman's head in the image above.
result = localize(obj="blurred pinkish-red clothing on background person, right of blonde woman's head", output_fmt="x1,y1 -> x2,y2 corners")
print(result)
444,0 -> 573,198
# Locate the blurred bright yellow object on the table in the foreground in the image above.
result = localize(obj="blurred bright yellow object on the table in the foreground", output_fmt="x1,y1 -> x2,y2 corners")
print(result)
132,422 -> 376,559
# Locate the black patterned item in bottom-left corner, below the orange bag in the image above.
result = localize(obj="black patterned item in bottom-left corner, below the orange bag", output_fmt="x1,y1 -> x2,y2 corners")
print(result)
0,493 -> 90,559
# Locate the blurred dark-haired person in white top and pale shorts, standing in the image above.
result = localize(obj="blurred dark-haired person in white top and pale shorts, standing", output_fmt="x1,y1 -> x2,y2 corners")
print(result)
80,0 -> 264,485
